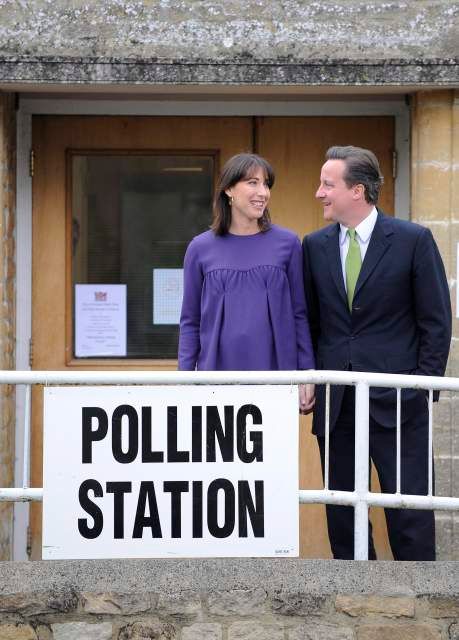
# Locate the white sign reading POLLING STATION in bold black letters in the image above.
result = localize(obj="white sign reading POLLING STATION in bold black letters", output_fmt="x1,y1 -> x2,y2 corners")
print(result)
43,385 -> 298,559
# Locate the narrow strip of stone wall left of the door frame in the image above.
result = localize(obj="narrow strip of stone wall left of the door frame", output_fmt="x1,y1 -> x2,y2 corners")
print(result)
0,93 -> 16,564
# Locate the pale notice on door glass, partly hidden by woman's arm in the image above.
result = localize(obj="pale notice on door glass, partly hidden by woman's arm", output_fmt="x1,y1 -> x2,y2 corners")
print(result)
153,269 -> 183,324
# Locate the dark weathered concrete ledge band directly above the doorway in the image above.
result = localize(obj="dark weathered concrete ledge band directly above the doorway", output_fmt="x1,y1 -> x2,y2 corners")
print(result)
0,57 -> 459,88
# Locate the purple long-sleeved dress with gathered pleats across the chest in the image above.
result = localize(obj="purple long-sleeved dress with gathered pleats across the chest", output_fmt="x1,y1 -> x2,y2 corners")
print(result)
178,225 -> 314,371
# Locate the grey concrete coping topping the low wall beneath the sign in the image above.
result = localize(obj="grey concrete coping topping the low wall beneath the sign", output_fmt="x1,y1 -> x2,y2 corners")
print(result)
0,558 -> 459,597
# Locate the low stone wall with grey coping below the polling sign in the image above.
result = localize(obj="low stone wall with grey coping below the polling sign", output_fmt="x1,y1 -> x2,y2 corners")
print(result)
0,559 -> 459,640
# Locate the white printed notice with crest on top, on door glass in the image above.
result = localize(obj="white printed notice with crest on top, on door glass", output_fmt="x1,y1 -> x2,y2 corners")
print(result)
75,284 -> 126,358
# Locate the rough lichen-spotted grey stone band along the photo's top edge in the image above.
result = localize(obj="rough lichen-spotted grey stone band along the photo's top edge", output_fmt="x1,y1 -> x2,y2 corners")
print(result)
0,0 -> 459,61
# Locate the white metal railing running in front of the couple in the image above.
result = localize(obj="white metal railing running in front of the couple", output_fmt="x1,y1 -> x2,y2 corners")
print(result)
0,371 -> 459,560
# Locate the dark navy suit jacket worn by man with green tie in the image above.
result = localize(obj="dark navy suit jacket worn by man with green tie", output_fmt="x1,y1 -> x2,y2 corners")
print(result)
303,211 -> 451,435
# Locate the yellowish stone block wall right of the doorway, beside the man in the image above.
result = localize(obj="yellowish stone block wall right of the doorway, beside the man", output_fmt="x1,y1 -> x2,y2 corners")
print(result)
411,91 -> 459,560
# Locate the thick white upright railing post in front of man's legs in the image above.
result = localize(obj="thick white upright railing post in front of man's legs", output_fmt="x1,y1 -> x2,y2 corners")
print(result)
354,382 -> 370,560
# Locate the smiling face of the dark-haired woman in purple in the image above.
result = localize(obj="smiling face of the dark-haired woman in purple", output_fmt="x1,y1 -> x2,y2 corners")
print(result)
225,167 -> 271,222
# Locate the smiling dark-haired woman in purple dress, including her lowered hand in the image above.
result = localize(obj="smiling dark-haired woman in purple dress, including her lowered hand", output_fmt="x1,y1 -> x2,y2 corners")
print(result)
179,153 -> 314,413
